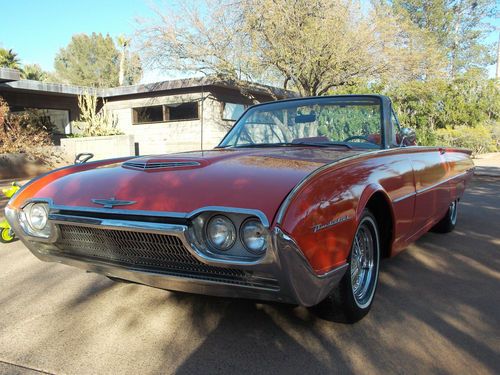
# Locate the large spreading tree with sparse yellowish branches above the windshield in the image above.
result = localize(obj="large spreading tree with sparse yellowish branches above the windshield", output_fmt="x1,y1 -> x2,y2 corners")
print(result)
139,0 -> 448,95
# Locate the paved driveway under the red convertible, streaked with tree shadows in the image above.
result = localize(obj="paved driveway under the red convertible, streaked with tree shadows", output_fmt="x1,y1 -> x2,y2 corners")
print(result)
0,177 -> 500,374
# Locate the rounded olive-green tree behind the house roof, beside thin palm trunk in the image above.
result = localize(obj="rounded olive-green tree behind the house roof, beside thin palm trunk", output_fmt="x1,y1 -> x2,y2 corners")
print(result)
54,33 -> 142,87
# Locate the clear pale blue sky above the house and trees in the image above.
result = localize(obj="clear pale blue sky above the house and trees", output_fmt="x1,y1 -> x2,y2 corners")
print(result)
0,0 -> 500,83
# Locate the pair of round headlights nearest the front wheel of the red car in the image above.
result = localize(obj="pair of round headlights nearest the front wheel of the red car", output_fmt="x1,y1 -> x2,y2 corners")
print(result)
205,215 -> 267,255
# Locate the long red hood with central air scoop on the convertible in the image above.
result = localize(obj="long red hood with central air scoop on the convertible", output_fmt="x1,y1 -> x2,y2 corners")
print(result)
28,147 -> 359,222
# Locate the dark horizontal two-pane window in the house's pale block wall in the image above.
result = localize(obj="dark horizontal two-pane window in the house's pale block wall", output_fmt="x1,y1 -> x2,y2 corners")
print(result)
132,102 -> 199,125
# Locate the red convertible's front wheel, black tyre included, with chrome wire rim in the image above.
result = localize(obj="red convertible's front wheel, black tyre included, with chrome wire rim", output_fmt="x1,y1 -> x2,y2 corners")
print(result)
318,209 -> 380,323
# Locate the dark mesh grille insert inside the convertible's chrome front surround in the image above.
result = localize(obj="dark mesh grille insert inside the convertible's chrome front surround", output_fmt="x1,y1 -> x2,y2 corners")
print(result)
55,224 -> 277,289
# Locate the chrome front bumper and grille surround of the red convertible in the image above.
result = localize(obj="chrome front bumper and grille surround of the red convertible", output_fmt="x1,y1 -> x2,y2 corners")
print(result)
6,207 -> 347,306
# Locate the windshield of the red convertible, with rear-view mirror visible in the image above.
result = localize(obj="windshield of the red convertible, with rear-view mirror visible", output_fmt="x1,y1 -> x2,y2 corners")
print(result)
219,97 -> 382,148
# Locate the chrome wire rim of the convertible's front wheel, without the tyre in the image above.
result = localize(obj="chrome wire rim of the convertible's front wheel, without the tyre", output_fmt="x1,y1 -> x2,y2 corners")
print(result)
350,217 -> 379,308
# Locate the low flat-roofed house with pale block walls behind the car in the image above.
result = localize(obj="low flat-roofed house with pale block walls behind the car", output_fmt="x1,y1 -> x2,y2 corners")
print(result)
0,69 -> 294,155
